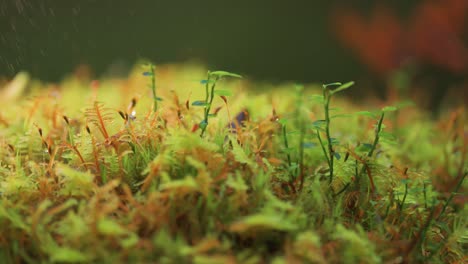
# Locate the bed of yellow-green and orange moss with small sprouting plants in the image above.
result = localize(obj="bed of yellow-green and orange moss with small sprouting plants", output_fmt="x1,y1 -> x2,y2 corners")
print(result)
0,64 -> 468,263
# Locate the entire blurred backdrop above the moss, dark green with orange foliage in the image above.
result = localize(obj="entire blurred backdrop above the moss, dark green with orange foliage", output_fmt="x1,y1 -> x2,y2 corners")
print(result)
0,0 -> 468,107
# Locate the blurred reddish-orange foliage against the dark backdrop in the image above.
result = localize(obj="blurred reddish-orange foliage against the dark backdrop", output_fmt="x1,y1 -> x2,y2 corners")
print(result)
332,0 -> 468,77
